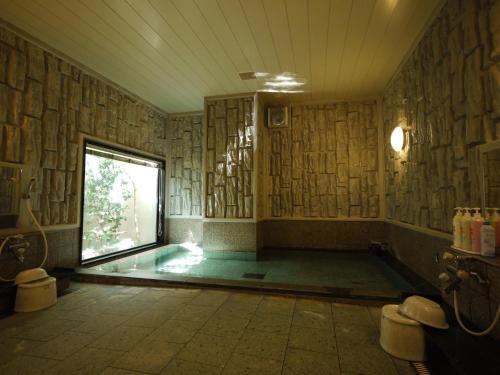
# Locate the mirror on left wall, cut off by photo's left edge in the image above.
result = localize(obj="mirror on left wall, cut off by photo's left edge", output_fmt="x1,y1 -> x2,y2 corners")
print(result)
0,164 -> 21,229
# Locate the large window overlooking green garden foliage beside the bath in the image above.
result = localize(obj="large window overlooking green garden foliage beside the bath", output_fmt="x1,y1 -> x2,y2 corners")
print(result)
81,141 -> 164,263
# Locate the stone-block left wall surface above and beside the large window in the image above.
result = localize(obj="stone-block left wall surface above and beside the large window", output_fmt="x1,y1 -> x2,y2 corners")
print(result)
0,27 -> 167,225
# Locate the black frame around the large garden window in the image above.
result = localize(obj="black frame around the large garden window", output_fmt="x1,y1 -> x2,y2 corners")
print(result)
78,139 -> 166,266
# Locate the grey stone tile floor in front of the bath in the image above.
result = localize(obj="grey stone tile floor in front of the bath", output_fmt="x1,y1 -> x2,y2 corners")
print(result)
0,283 -> 415,375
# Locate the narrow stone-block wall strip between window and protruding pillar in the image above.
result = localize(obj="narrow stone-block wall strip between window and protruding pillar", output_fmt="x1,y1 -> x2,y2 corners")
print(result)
167,114 -> 202,217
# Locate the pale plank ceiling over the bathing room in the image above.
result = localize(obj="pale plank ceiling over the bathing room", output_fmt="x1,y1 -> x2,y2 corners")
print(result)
0,0 -> 442,112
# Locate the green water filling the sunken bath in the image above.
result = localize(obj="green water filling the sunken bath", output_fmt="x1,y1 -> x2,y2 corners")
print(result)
88,244 -> 414,292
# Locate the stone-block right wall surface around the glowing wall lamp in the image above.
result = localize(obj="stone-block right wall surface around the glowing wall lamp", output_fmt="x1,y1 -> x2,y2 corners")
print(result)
383,0 -> 500,232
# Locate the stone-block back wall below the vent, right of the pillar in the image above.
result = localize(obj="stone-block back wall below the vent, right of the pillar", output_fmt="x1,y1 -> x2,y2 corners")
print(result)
264,101 -> 379,218
